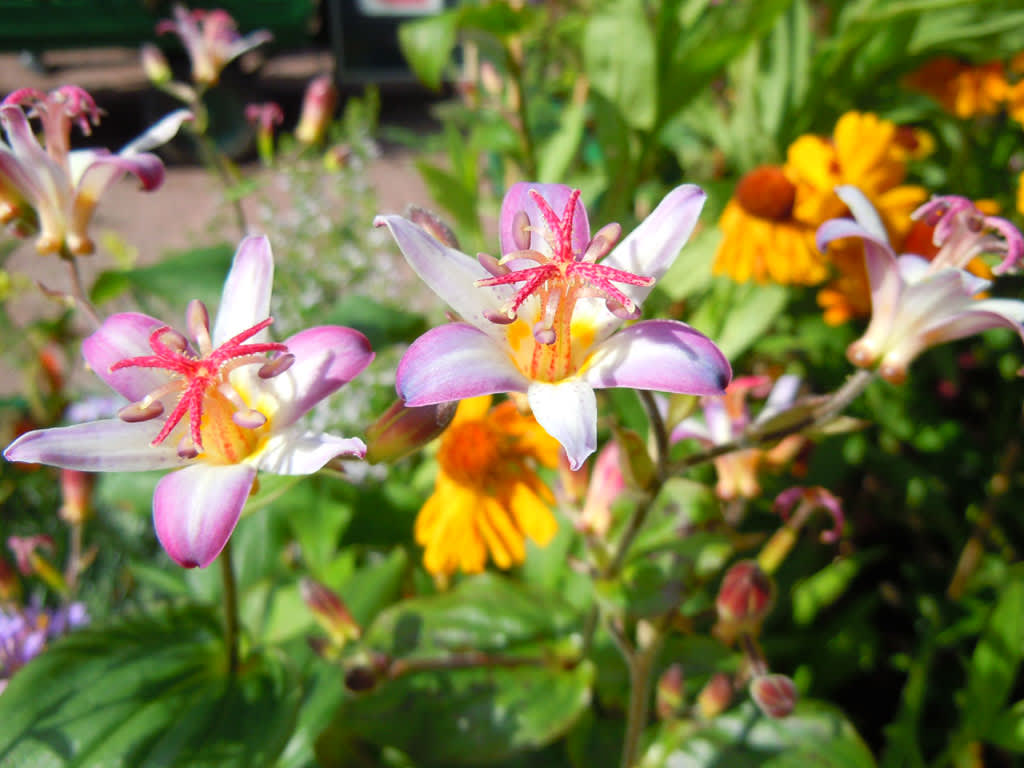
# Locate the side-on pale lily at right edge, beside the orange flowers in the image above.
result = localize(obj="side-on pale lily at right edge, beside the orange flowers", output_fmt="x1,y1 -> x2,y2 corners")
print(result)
817,186 -> 1024,384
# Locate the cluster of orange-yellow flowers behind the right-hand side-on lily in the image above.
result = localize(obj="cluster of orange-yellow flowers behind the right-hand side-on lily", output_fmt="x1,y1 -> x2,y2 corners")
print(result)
713,112 -> 933,325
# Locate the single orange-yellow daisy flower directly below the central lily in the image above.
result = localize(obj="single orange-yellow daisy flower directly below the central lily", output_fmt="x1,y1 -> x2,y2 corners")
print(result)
415,396 -> 561,575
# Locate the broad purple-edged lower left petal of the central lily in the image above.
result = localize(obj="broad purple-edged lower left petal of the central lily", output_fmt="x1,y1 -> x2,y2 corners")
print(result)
395,323 -> 528,406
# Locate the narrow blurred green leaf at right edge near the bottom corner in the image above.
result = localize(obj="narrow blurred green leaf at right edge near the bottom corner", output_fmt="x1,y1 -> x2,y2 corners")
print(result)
961,578 -> 1024,741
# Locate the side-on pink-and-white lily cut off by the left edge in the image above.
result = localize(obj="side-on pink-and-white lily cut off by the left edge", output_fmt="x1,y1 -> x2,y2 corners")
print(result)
0,85 -> 191,256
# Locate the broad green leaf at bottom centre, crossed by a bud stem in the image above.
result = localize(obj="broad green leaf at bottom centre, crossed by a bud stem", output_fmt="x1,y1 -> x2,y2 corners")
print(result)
326,573 -> 594,766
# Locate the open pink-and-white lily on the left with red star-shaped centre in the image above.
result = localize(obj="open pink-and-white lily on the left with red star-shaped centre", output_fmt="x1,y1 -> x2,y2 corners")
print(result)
4,237 -> 374,567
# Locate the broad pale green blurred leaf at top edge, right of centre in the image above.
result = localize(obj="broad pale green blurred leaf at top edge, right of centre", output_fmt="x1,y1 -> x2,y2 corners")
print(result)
583,0 -> 657,130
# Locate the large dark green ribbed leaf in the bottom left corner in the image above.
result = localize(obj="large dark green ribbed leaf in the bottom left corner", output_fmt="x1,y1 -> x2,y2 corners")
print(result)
0,610 -> 301,768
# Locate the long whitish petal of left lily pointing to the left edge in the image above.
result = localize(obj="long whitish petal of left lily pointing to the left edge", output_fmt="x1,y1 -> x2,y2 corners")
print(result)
3,419 -> 183,472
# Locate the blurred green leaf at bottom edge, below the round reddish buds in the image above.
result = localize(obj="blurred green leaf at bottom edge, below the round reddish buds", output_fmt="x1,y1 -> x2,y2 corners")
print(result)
640,701 -> 874,768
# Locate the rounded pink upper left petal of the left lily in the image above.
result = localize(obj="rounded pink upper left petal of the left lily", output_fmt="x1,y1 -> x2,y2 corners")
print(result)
82,312 -> 168,401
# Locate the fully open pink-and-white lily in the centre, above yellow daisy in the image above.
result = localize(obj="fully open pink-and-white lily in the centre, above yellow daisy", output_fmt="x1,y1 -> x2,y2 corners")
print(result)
375,182 -> 732,469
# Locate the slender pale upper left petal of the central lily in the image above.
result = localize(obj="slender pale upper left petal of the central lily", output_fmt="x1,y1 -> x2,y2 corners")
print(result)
374,216 -> 505,339
